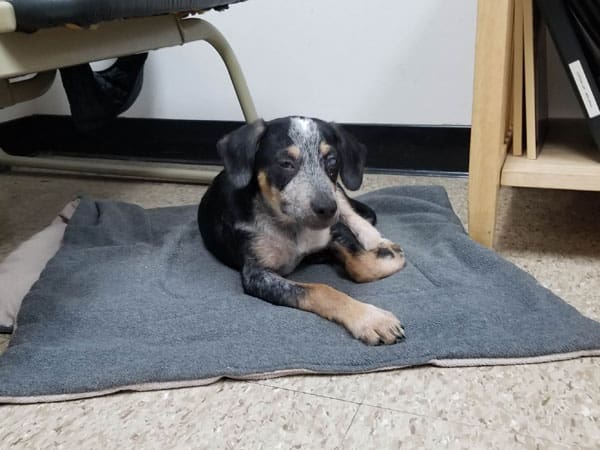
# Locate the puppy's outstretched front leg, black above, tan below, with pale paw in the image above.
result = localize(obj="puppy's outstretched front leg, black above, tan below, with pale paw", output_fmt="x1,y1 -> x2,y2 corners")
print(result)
242,262 -> 404,345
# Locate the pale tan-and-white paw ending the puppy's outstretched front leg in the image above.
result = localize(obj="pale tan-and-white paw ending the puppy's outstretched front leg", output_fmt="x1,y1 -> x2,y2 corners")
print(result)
349,304 -> 404,345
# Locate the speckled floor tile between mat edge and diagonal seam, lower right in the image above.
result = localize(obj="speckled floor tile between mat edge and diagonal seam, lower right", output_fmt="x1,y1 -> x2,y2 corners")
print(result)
260,358 -> 600,446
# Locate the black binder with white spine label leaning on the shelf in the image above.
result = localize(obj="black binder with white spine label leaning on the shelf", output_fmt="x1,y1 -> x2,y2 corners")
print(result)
536,0 -> 600,150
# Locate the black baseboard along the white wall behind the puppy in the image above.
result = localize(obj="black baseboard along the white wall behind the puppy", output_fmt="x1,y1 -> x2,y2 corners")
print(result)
0,115 -> 470,174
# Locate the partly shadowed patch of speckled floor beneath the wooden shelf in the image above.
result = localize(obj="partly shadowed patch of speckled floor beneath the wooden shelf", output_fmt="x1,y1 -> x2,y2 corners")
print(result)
496,189 -> 600,320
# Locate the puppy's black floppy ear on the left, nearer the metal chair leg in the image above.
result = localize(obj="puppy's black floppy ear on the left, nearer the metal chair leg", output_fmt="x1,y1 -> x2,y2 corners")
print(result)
217,119 -> 267,189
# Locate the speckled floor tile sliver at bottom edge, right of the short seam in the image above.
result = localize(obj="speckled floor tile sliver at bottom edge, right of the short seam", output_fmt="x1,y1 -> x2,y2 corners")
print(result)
343,405 -> 569,450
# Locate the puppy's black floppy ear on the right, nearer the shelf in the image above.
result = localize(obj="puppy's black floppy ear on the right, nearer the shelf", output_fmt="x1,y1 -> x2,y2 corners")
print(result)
331,123 -> 367,191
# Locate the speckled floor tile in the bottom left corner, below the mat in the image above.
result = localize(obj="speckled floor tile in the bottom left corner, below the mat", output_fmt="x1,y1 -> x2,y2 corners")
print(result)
0,381 -> 358,449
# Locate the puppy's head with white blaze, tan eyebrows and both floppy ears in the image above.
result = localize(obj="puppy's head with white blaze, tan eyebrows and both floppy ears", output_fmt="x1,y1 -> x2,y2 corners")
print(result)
217,117 -> 367,229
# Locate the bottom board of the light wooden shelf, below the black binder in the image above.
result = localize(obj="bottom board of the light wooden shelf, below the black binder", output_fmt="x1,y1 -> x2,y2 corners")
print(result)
500,120 -> 600,191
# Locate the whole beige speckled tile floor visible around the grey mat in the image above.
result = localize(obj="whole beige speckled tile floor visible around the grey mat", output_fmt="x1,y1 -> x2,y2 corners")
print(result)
0,168 -> 600,449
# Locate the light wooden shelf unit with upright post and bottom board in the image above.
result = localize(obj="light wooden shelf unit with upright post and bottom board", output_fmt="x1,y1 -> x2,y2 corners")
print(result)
469,0 -> 600,247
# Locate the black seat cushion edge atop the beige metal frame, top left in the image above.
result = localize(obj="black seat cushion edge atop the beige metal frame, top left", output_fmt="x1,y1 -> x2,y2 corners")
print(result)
9,0 -> 244,31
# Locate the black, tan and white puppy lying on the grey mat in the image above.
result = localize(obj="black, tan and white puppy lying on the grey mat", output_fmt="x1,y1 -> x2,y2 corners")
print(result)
198,117 -> 404,345
